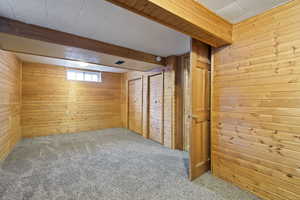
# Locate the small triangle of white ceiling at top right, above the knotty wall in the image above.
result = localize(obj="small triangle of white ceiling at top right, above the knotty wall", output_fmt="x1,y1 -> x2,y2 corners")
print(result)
196,0 -> 290,24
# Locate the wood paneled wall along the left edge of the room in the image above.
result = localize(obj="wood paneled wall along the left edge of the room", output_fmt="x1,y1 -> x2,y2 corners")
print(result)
0,50 -> 22,160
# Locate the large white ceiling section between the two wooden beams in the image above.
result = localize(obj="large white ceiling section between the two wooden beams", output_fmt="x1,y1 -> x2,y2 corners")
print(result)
0,0 -> 190,56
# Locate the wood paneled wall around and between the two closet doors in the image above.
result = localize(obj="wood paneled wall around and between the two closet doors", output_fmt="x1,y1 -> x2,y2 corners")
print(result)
122,57 -> 176,148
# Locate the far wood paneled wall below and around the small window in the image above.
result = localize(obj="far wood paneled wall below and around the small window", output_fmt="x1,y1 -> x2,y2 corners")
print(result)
21,63 -> 122,137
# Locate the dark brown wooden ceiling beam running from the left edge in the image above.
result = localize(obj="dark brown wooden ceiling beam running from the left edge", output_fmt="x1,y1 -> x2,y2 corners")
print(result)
0,17 -> 165,65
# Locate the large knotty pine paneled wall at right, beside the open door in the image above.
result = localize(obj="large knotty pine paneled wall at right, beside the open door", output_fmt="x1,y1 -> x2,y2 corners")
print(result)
212,0 -> 300,200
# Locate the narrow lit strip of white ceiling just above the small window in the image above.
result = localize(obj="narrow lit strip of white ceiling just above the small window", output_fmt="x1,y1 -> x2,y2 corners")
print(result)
15,53 -> 129,73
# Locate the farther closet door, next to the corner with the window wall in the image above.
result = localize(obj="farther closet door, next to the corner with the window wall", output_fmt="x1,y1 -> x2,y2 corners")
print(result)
128,78 -> 143,135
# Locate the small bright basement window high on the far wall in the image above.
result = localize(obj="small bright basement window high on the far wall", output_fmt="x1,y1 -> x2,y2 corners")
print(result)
67,70 -> 102,82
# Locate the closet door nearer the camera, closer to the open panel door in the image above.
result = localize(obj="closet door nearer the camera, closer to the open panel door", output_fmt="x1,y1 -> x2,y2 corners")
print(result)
148,73 -> 164,144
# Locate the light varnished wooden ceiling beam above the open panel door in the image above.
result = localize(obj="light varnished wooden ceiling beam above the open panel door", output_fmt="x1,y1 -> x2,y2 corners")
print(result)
106,0 -> 232,47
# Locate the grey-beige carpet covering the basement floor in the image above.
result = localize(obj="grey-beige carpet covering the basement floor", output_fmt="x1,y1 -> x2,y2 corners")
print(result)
0,129 -> 258,200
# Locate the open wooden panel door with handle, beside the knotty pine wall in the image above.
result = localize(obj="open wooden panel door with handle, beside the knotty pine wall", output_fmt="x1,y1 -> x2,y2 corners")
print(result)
189,40 -> 210,180
